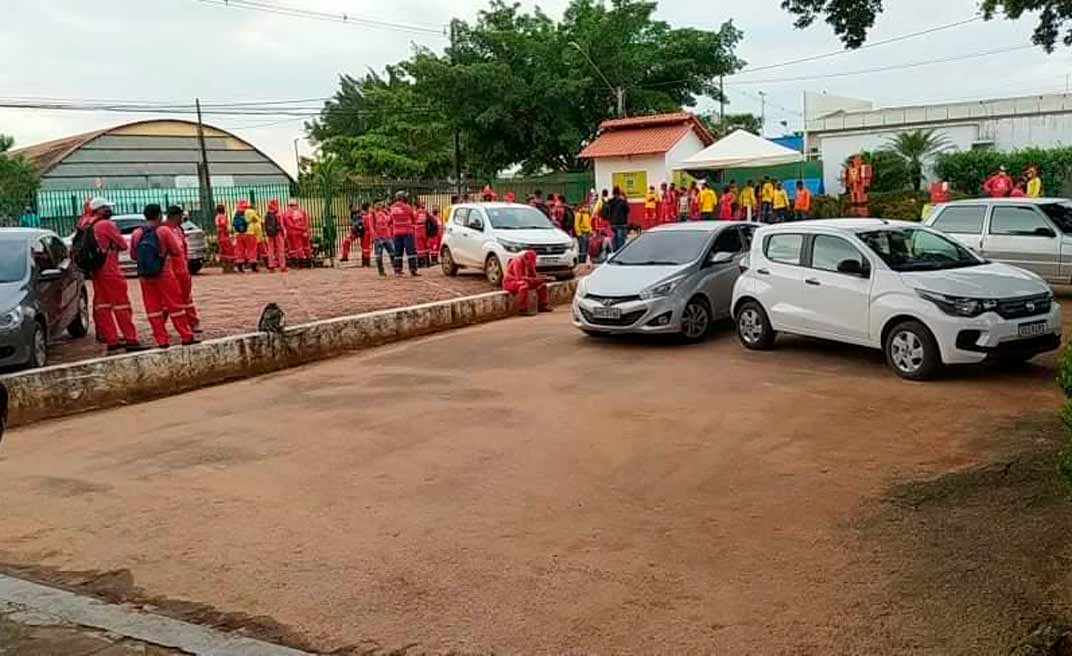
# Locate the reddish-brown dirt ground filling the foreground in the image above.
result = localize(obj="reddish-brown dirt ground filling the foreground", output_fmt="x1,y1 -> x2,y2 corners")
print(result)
0,311 -> 1072,656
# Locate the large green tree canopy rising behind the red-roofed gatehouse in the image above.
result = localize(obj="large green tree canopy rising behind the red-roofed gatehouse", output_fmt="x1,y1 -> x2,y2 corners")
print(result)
308,0 -> 743,177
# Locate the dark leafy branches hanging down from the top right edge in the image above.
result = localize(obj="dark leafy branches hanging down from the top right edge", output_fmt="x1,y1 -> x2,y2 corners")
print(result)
781,0 -> 1072,53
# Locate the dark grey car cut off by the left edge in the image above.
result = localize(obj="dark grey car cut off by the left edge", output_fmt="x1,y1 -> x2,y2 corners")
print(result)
0,228 -> 90,367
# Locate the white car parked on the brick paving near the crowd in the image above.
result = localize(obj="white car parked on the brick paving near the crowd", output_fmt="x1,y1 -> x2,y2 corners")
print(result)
440,203 -> 577,287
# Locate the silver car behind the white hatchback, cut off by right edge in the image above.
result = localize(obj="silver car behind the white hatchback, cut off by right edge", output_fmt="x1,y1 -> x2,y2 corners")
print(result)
924,198 -> 1072,284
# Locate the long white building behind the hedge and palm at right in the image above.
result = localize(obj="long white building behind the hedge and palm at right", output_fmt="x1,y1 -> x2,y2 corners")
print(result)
806,93 -> 1072,194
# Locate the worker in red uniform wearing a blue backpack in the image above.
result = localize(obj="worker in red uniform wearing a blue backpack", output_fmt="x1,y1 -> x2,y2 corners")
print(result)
131,205 -> 197,348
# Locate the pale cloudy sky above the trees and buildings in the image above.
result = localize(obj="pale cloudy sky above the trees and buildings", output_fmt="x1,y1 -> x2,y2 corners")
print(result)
0,0 -> 1072,176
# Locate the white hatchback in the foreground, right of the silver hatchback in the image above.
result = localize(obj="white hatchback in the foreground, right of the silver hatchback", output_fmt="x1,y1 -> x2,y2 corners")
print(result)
733,219 -> 1061,379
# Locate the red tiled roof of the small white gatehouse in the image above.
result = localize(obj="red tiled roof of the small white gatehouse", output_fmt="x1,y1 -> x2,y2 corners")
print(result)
578,111 -> 715,159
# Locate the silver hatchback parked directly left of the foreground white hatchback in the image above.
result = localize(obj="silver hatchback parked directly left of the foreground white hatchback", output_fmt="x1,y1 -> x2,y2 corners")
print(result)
572,221 -> 757,342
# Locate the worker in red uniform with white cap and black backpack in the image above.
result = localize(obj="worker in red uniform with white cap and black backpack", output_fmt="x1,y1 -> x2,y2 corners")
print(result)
75,198 -> 145,353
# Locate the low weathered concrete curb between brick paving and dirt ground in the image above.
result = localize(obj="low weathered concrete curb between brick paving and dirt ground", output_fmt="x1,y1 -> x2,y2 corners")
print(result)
0,281 -> 577,427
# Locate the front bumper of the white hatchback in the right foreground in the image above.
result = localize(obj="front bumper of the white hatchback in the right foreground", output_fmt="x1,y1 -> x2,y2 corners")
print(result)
930,302 -> 1061,364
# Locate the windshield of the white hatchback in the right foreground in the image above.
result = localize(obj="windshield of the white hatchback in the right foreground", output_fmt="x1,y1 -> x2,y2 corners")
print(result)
859,227 -> 983,271
